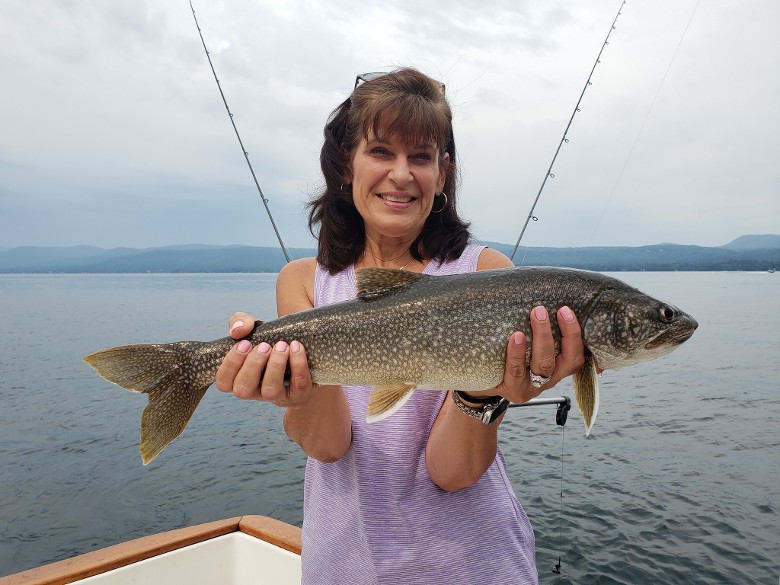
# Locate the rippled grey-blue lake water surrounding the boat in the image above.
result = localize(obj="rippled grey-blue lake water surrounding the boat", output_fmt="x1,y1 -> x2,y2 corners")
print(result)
0,273 -> 780,585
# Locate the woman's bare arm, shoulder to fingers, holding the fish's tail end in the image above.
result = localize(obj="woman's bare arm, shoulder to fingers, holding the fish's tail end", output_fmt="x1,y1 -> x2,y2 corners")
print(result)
212,258 -> 352,462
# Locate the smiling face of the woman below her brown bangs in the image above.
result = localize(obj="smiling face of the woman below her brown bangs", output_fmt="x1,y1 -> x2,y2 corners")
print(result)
349,135 -> 449,239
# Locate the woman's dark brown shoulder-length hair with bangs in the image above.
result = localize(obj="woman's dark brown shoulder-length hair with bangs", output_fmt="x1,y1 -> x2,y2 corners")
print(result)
308,68 -> 470,274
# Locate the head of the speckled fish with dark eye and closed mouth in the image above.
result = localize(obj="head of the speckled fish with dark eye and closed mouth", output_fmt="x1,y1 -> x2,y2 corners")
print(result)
582,288 -> 698,370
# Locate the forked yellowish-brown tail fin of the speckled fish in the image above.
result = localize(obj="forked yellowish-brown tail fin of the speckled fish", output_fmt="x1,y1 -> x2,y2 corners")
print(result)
84,339 -> 235,465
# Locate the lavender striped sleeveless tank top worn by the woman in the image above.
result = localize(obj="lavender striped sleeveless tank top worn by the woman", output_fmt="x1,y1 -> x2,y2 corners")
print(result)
301,245 -> 538,585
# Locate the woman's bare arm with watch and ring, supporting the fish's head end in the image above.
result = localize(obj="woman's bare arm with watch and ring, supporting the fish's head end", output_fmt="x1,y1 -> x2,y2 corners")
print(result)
425,248 -> 584,491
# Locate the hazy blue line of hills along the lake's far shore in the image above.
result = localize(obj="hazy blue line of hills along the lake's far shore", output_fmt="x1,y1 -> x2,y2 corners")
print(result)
0,235 -> 780,274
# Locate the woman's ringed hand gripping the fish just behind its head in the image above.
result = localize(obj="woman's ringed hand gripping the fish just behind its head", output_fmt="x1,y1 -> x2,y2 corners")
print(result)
484,306 -> 585,404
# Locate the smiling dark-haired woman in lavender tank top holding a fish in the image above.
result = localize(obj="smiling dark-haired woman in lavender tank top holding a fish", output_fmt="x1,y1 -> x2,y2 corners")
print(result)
217,69 -> 583,585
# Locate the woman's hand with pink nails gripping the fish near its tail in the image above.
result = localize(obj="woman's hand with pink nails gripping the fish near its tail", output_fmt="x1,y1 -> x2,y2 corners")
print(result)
216,313 -> 313,408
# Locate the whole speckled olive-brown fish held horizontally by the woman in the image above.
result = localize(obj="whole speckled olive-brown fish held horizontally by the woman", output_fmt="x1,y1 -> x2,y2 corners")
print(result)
84,266 -> 698,465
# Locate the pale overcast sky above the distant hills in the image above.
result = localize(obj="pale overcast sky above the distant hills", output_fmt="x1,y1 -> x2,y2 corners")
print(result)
0,0 -> 780,248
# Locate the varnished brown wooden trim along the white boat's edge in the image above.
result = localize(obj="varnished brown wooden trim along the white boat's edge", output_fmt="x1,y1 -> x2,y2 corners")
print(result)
0,516 -> 301,585
